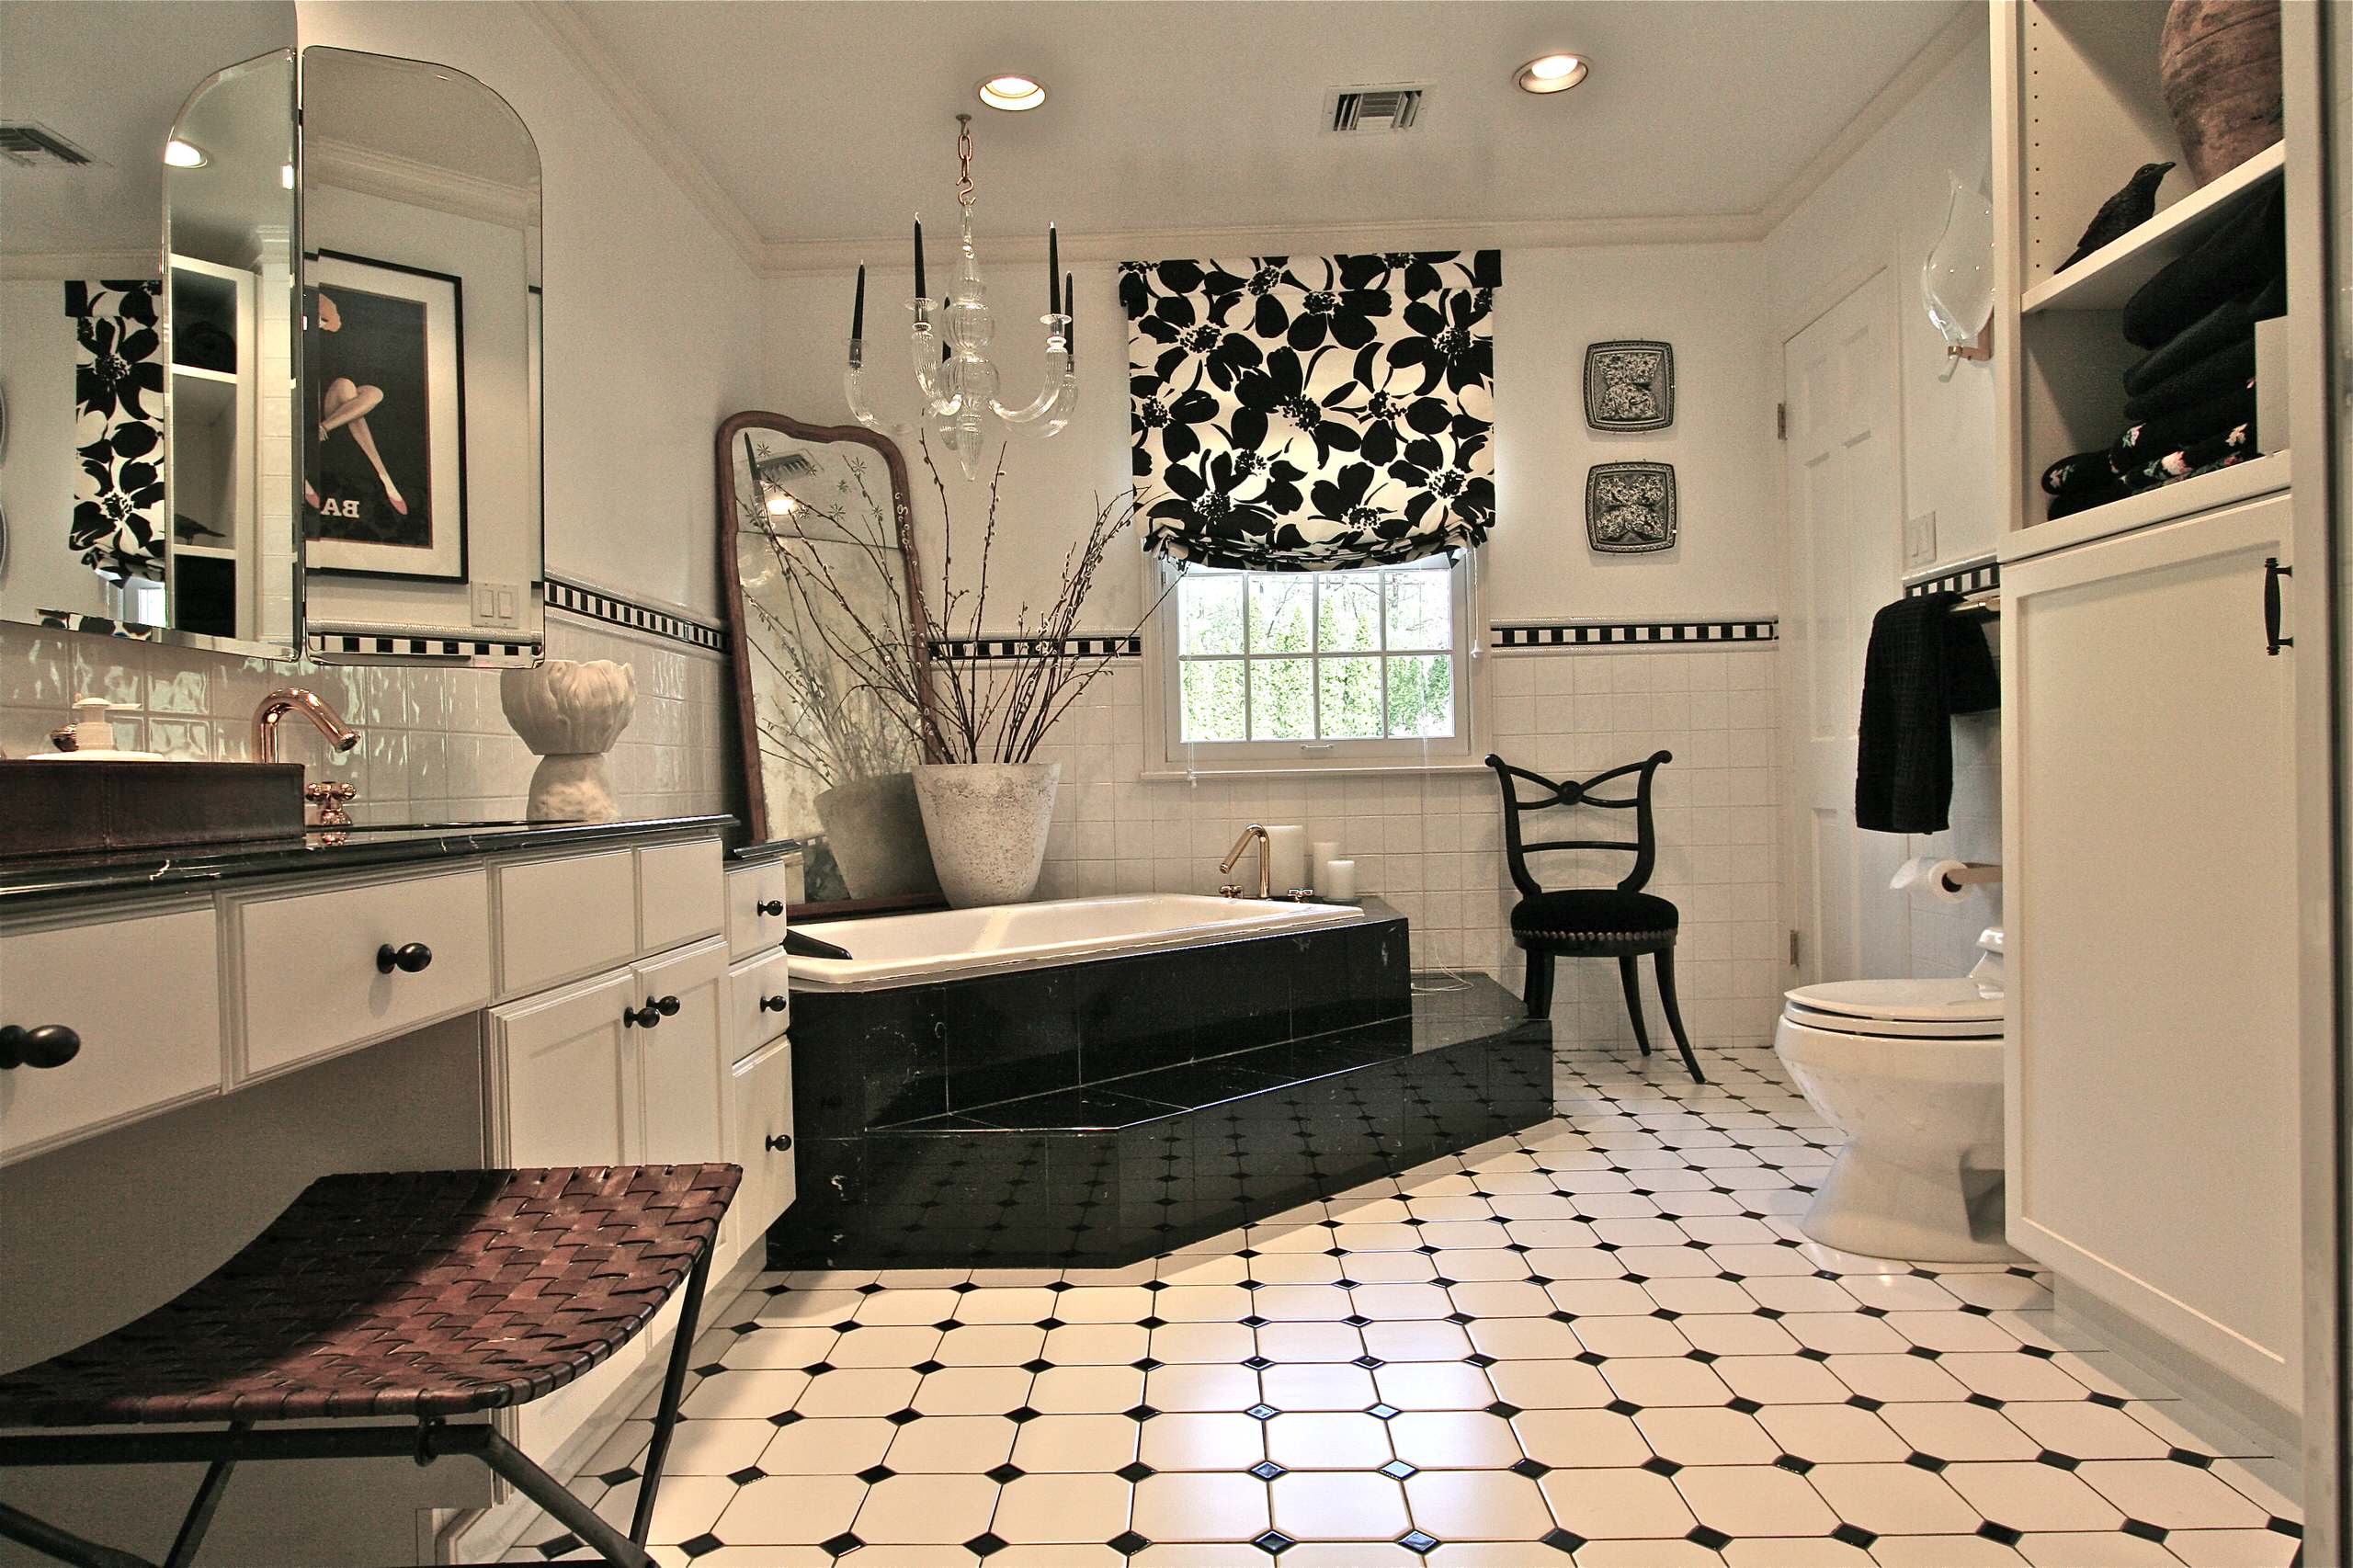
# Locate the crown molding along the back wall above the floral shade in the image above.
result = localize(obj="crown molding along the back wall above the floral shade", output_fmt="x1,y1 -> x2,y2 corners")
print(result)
760,212 -> 1765,278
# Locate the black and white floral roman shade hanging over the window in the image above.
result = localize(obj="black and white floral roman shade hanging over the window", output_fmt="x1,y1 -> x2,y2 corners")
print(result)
1120,250 -> 1504,572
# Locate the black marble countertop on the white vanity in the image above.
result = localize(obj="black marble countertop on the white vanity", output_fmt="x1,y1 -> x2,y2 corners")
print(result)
0,817 -> 743,911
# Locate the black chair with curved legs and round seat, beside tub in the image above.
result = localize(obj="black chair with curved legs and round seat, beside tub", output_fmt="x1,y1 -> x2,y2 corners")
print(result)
1487,751 -> 1706,1083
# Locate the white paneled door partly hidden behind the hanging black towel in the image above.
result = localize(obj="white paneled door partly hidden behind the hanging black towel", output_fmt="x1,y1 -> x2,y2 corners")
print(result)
1781,271 -> 1911,980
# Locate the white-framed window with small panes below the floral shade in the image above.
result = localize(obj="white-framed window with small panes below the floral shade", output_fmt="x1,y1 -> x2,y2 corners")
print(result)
1163,556 -> 1471,767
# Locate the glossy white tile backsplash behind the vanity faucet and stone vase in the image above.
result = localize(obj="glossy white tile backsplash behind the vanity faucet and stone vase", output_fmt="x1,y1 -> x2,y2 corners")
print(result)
0,612 -> 736,822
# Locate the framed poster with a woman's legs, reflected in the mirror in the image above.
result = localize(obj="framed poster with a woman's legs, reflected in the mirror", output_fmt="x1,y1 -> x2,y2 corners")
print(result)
303,250 -> 466,582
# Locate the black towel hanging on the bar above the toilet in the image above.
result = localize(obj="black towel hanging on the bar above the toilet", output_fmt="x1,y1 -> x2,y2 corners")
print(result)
1854,594 -> 2003,834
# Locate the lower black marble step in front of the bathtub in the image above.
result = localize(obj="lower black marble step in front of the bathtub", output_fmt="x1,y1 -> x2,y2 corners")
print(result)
769,977 -> 1553,1267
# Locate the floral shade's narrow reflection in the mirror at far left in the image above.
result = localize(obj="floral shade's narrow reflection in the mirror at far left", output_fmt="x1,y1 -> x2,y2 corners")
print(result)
66,278 -> 165,577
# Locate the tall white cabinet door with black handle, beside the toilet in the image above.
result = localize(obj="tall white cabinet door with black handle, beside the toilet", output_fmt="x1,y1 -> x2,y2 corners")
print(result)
2003,496 -> 2302,1410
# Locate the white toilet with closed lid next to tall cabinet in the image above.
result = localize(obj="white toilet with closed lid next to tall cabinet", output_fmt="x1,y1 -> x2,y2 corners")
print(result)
1774,927 -> 2021,1262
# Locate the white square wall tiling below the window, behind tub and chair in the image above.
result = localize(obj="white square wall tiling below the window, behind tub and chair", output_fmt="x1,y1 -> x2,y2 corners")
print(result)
1016,642 -> 1779,1045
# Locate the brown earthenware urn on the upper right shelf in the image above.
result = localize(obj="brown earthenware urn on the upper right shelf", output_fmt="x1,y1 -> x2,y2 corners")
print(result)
2158,0 -> 2282,186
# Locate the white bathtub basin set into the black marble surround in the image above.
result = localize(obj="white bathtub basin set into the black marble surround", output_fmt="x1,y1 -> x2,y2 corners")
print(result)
789,892 -> 1365,991
